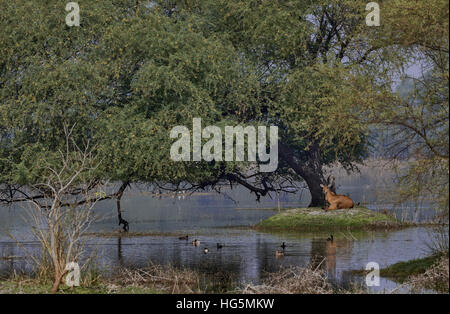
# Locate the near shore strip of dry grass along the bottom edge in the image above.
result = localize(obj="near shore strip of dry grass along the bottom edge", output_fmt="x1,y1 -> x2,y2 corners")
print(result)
0,253 -> 448,294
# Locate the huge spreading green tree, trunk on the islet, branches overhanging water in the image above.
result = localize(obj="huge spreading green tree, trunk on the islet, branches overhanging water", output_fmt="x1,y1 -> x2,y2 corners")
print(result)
0,1 -> 384,213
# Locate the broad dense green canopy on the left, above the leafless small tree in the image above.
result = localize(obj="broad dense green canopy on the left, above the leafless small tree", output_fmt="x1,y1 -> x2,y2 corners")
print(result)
0,1 -> 258,184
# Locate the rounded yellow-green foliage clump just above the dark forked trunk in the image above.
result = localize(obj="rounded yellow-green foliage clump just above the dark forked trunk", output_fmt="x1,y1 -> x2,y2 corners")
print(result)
273,65 -> 367,166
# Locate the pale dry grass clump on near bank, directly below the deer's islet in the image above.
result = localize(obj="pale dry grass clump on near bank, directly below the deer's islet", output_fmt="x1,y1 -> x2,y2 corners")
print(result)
238,265 -> 333,294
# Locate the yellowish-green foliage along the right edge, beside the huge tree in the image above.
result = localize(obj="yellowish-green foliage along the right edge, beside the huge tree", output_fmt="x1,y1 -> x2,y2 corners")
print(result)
366,0 -> 449,213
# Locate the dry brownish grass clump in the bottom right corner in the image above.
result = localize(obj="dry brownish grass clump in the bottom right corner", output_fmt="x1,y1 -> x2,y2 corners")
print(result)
405,254 -> 449,293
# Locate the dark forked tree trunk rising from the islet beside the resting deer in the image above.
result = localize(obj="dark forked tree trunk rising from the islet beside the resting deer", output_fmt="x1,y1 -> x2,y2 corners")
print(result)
279,143 -> 326,207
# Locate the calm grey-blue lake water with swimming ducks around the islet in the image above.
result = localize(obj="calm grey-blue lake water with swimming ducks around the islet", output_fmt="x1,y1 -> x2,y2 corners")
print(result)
0,183 -> 442,291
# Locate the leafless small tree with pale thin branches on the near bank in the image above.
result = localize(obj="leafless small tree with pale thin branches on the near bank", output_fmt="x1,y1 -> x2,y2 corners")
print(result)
21,129 -> 104,292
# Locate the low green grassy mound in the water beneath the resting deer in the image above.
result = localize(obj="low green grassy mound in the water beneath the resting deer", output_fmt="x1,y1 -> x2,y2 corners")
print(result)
255,207 -> 406,232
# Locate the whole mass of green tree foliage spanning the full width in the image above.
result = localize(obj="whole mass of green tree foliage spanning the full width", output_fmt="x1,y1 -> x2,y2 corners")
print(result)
0,0 -> 448,221
